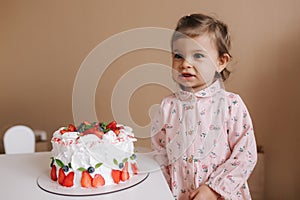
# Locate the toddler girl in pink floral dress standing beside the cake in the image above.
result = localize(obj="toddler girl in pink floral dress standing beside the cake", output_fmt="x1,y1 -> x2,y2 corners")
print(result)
152,14 -> 257,200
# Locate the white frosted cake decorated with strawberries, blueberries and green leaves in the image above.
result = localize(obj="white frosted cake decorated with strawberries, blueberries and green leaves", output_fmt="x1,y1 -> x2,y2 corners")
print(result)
50,121 -> 138,188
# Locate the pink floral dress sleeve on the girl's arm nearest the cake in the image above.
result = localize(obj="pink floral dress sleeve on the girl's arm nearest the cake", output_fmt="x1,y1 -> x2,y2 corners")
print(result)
151,102 -> 171,185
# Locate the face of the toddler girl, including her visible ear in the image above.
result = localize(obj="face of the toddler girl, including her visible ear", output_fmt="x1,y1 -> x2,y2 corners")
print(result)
172,34 -> 229,92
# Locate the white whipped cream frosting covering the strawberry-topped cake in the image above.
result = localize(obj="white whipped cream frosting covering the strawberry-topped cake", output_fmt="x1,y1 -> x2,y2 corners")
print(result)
51,124 -> 136,187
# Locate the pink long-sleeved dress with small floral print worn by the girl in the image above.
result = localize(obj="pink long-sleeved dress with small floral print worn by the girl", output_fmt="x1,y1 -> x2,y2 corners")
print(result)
152,81 -> 257,200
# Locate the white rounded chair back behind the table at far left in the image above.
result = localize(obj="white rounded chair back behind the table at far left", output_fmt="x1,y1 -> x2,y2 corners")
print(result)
3,125 -> 35,154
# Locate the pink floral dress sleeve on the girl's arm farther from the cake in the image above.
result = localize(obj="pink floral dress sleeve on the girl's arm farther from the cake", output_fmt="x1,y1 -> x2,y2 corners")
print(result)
206,95 -> 257,197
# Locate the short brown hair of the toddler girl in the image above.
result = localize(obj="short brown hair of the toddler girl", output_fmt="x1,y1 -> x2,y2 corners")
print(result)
171,14 -> 231,80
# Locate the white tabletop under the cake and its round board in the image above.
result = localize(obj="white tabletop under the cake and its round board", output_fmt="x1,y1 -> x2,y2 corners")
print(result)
0,152 -> 174,200
